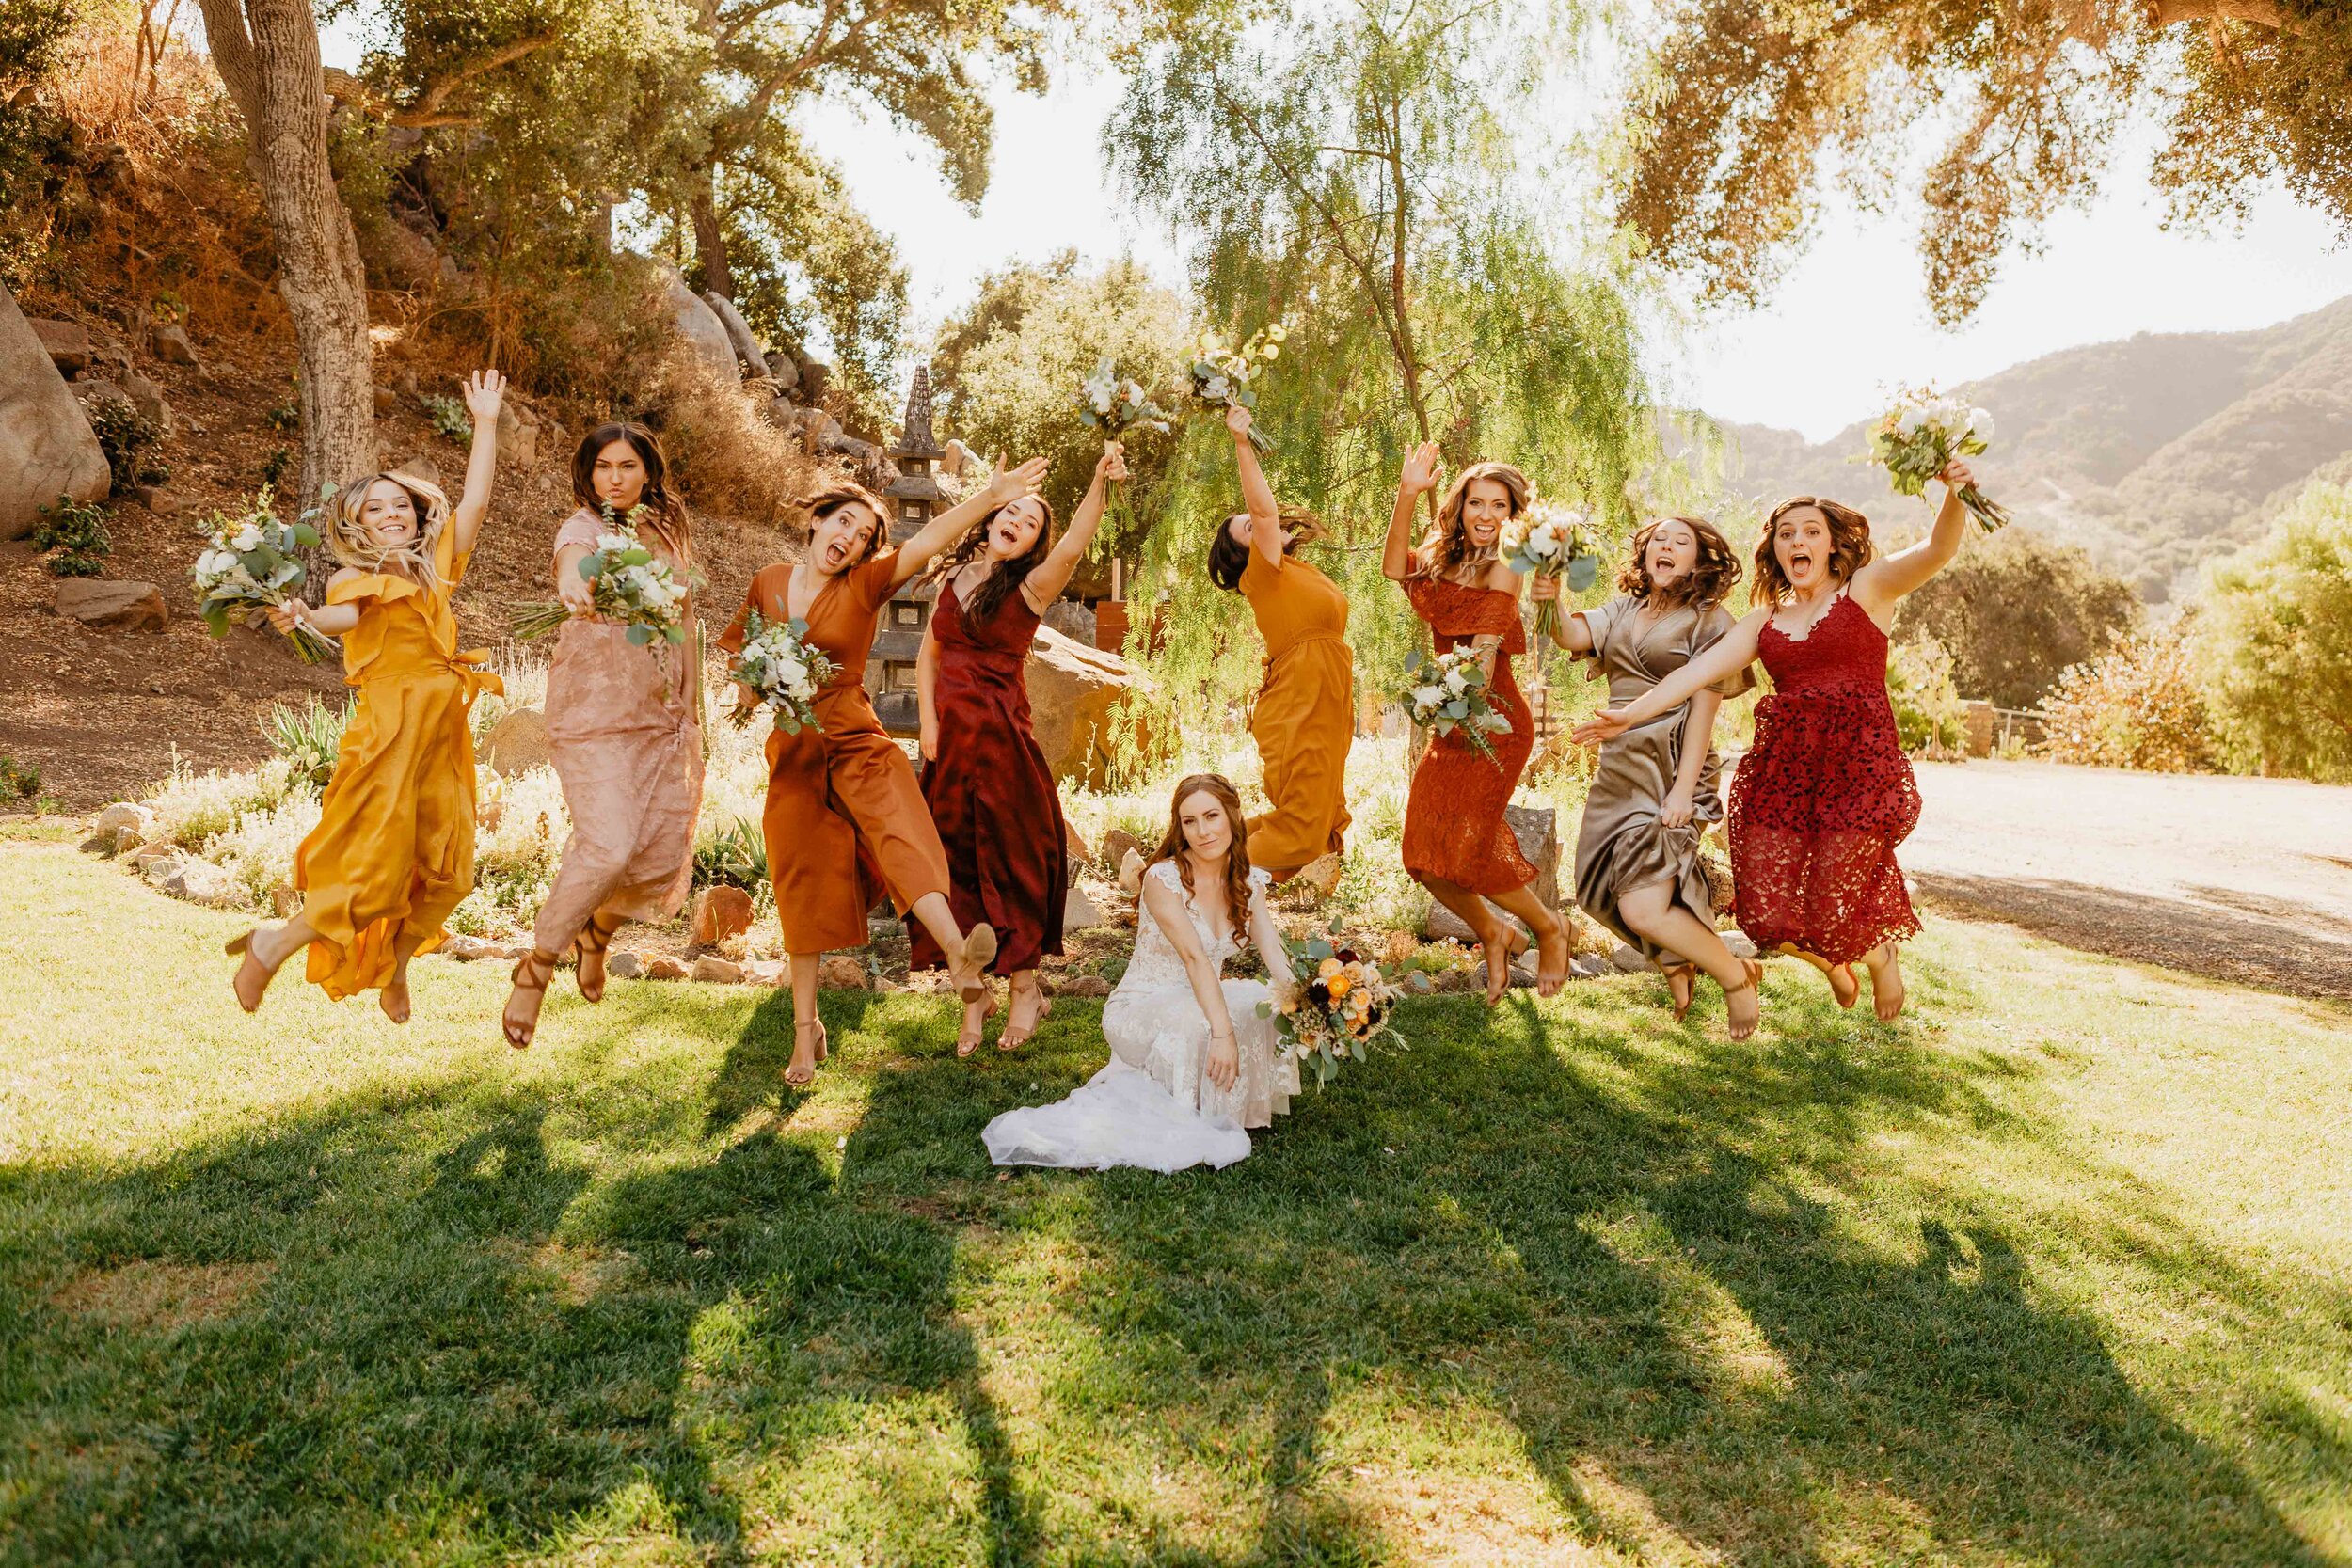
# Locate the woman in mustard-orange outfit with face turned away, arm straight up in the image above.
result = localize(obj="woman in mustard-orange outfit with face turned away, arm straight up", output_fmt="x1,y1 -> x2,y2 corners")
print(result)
1209,404 -> 1355,881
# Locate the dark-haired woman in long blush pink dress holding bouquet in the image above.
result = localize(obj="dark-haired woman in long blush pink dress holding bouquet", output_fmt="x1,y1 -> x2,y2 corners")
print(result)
503,423 -> 704,1051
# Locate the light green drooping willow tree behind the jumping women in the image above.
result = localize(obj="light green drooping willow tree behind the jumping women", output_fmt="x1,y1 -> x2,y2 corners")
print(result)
1104,0 -> 1656,719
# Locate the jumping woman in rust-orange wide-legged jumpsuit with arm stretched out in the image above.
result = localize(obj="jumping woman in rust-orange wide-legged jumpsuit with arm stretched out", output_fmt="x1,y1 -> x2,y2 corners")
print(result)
720,458 -> 1047,1086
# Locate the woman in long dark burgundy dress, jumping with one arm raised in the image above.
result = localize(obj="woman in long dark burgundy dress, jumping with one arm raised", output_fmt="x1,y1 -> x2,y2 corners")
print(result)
913,442 -> 1127,1055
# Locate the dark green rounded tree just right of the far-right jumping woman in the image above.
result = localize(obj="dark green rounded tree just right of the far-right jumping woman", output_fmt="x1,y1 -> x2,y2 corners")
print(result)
1899,529 -> 2140,707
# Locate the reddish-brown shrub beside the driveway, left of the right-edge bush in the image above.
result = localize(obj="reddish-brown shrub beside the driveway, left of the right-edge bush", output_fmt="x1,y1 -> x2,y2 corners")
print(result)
2042,627 -> 2216,773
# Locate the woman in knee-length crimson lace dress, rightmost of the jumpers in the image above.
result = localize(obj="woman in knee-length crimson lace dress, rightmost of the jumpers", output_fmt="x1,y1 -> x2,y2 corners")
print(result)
1576,463 -> 1974,1018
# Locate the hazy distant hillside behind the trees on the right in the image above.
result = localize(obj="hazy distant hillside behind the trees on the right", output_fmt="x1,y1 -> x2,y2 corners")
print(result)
1722,298 -> 2352,602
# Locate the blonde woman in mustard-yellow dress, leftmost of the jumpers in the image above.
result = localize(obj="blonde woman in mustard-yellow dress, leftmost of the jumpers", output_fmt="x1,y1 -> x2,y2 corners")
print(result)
229,372 -> 506,1022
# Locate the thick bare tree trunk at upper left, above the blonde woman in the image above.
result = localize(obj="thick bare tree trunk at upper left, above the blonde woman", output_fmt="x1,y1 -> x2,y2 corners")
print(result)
202,0 -> 376,505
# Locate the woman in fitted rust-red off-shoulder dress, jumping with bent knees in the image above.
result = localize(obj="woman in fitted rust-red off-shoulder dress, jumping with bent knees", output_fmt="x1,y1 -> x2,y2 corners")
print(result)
1381,442 -> 1569,1006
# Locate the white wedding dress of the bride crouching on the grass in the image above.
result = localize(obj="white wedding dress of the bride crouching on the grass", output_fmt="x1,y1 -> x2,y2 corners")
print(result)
981,861 -> 1298,1171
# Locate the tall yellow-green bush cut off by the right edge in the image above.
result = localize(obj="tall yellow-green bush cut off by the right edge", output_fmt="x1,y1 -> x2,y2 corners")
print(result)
2197,484 -> 2352,783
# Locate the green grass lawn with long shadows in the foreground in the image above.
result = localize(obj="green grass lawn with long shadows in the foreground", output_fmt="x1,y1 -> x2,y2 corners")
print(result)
0,842 -> 2352,1568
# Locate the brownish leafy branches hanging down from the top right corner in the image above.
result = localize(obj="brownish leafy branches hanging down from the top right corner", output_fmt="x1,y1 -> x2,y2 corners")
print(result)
1618,0 -> 2352,322
